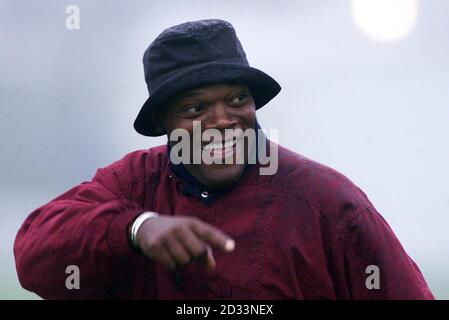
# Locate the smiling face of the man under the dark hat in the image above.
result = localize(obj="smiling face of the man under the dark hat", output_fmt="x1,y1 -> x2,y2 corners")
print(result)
162,84 -> 256,188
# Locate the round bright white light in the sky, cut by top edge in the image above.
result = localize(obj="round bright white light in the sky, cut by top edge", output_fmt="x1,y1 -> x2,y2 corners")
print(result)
351,0 -> 418,42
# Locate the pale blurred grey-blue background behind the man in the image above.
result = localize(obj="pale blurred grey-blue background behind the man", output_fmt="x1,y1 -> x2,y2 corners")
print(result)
0,0 -> 449,299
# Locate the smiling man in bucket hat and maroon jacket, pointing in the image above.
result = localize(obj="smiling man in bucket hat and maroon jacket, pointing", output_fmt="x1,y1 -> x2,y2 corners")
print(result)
14,20 -> 433,299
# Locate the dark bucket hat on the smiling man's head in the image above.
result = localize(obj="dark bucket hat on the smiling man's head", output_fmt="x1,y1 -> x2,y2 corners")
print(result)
134,19 -> 281,136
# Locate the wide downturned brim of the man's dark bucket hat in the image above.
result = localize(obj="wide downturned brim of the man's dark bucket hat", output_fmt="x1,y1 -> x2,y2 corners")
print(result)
134,62 -> 281,137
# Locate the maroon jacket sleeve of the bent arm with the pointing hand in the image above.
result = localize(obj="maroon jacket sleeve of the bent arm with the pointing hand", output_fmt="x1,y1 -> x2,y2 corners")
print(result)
14,162 -> 143,299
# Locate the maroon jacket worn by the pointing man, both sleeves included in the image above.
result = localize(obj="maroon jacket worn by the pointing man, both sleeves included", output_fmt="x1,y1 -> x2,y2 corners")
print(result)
14,146 -> 433,299
